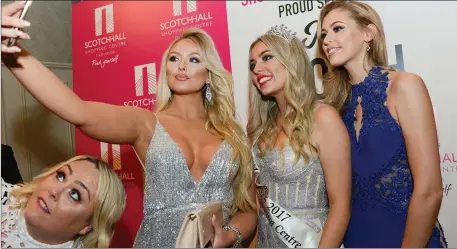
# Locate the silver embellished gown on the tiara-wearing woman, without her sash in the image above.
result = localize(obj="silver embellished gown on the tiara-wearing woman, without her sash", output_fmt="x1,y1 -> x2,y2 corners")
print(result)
254,146 -> 328,248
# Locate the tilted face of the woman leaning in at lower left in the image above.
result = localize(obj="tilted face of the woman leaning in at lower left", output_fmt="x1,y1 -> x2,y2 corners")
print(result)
24,160 -> 99,238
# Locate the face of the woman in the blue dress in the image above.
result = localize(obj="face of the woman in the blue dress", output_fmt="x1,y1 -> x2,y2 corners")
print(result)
320,9 -> 371,67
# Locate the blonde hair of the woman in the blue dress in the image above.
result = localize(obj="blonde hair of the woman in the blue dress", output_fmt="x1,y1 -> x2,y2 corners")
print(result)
317,0 -> 393,113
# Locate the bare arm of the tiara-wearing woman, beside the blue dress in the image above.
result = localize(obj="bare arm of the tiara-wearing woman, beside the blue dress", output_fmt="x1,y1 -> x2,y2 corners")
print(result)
312,105 -> 352,248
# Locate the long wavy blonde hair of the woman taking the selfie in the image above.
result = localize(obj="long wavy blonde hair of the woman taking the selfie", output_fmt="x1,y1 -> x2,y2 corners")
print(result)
157,28 -> 255,215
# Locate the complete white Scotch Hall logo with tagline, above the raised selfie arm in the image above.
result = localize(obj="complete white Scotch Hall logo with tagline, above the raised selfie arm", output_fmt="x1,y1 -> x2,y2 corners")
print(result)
84,4 -> 127,68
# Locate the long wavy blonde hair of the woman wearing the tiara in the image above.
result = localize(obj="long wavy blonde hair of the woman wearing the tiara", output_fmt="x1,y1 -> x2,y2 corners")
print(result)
247,34 -> 318,162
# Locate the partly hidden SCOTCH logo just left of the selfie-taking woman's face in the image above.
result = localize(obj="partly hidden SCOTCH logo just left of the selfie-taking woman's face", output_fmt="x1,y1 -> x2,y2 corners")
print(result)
124,62 -> 157,109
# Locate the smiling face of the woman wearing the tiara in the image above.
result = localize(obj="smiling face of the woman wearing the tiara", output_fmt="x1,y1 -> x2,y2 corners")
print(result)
249,41 -> 287,96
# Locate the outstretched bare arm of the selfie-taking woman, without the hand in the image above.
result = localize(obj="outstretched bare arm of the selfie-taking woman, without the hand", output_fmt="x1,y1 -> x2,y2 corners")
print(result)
2,48 -> 152,145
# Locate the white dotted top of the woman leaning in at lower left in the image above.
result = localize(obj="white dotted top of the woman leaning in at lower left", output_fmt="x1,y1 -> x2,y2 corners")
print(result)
1,178 -> 74,248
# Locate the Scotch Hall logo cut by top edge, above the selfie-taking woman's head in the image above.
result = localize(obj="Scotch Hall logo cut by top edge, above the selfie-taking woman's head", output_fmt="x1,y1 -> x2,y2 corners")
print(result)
160,0 -> 213,36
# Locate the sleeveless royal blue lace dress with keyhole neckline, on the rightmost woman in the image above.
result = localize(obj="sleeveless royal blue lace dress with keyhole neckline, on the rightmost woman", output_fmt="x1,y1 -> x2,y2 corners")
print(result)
343,67 -> 447,247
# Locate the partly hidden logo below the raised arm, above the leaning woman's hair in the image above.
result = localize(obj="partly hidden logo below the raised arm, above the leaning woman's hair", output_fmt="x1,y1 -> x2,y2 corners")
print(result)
100,142 -> 135,181
